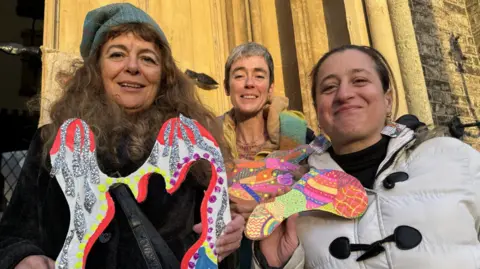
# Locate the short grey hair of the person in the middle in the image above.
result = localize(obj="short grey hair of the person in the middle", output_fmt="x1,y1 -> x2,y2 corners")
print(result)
223,42 -> 275,93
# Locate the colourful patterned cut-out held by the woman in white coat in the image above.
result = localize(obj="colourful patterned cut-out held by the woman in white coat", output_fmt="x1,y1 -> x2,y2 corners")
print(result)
246,169 -> 368,240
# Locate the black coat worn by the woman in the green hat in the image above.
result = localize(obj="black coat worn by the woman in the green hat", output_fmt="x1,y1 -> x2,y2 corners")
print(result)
0,126 -> 232,269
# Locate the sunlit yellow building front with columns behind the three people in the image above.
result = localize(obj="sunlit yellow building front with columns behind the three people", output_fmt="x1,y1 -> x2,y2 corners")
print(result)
40,0 -> 480,150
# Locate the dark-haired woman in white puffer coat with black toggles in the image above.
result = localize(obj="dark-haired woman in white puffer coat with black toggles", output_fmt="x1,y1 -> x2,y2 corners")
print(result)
253,45 -> 480,269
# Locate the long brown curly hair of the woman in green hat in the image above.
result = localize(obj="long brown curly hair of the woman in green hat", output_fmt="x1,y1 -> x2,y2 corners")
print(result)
41,23 -> 232,178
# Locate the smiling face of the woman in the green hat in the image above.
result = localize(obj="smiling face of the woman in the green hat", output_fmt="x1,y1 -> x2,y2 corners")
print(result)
100,33 -> 162,112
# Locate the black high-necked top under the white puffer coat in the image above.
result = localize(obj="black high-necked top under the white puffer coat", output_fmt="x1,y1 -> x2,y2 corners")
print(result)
328,136 -> 390,189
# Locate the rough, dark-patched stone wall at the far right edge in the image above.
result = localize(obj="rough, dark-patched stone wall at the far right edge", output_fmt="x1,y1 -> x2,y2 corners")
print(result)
410,0 -> 480,149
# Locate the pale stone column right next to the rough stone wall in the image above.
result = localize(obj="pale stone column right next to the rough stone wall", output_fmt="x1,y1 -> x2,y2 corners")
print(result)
388,0 -> 433,124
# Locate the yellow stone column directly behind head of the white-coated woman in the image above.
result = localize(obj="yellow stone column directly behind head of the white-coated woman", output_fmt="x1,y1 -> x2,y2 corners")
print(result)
365,0 -> 413,117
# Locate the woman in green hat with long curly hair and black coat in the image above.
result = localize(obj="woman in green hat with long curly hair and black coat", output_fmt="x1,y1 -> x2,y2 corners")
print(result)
0,4 -> 245,269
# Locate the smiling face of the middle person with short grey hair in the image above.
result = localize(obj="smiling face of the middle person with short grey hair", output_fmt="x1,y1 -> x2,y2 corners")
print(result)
227,56 -> 273,116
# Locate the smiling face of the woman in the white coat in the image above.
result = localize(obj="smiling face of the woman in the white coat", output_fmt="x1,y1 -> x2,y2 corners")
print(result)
315,49 -> 392,149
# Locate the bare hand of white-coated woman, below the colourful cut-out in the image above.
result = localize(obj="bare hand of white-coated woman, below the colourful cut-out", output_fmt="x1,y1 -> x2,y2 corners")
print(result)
260,214 -> 298,267
